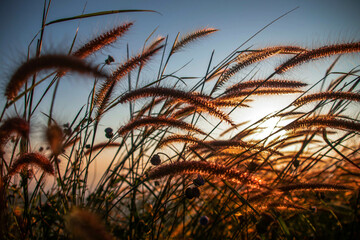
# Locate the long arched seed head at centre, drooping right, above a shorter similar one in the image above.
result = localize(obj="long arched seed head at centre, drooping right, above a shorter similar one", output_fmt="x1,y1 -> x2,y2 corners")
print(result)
119,87 -> 233,124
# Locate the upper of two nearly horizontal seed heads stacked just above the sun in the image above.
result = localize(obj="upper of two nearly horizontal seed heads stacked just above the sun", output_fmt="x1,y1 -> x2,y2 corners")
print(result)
226,79 -> 307,93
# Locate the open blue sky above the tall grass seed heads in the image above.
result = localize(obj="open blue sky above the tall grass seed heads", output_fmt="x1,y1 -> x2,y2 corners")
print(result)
0,0 -> 360,131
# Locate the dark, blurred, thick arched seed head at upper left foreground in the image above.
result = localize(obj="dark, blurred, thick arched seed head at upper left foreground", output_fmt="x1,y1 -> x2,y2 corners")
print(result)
5,54 -> 106,100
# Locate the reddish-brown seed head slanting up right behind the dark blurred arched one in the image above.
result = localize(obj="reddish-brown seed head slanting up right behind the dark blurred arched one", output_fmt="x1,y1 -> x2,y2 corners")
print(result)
73,22 -> 133,59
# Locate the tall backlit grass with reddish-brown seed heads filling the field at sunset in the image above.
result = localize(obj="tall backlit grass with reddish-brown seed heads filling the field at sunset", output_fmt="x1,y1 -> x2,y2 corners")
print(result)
0,4 -> 360,239
